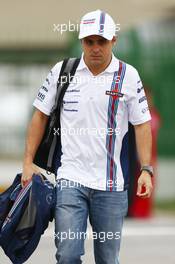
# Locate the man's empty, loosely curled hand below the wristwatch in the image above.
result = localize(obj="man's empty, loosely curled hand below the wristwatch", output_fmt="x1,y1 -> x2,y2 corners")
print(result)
137,171 -> 153,198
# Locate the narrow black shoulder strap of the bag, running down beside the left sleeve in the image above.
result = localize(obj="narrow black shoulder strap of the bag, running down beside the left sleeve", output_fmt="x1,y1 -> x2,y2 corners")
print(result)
47,58 -> 80,171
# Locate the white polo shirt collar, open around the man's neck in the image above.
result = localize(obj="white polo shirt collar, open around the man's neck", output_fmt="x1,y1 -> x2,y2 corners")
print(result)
77,53 -> 119,73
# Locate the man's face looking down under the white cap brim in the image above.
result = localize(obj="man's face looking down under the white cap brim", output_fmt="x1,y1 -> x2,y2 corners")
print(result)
82,35 -> 116,67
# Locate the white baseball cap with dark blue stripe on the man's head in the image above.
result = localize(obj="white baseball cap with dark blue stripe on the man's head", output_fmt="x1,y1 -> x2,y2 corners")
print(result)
78,10 -> 116,40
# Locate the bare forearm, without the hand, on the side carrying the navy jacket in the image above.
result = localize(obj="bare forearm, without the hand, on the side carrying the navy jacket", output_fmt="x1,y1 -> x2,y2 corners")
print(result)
23,110 -> 48,166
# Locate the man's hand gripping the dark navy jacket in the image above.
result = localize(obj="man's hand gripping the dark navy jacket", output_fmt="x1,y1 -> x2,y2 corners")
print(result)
21,163 -> 41,187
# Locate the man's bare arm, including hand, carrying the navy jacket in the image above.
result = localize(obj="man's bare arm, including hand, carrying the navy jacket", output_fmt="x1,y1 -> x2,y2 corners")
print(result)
21,110 -> 49,186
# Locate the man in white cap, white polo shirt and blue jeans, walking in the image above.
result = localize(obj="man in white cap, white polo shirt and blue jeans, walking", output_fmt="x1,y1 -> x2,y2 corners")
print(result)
22,10 -> 152,264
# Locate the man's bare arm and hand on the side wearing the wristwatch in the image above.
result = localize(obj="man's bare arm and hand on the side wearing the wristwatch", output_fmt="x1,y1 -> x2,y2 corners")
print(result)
134,122 -> 153,198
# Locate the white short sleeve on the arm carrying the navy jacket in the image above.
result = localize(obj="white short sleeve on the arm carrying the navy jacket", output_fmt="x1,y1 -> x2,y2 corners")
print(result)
33,62 -> 62,116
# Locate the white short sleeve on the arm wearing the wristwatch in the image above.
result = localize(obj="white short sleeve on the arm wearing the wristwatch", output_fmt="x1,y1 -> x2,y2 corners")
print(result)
128,70 -> 151,125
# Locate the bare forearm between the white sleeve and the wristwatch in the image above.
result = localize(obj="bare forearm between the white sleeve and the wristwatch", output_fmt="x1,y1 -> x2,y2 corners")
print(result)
134,122 -> 152,166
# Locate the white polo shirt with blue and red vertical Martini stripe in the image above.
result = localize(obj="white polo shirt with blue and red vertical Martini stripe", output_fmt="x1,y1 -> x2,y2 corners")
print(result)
33,55 -> 151,191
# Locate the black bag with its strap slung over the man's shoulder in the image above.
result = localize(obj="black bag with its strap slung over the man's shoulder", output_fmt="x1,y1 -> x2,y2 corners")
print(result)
34,58 -> 80,174
